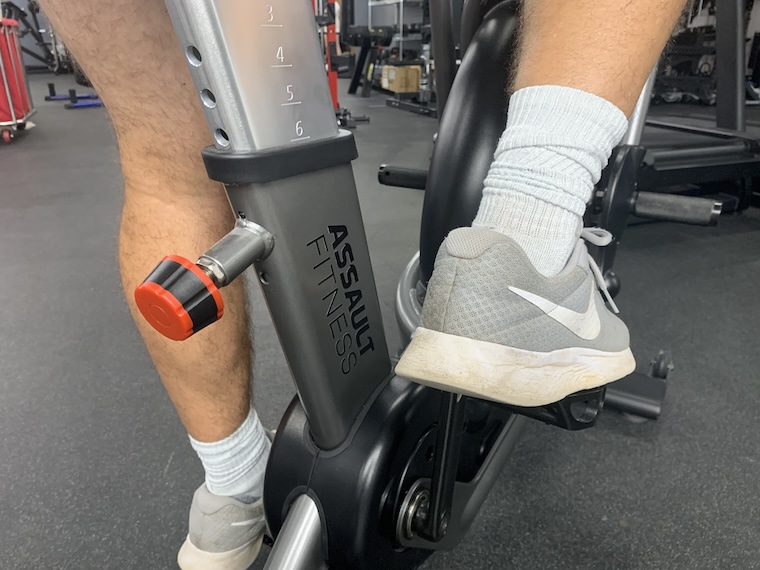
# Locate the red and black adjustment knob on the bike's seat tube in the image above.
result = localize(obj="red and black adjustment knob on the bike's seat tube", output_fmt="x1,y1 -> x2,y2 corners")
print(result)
135,255 -> 224,340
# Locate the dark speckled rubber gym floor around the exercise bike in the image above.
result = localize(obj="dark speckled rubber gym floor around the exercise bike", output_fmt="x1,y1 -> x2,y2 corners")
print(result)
0,76 -> 760,570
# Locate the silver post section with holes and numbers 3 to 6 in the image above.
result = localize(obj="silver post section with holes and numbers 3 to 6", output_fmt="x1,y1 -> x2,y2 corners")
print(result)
166,0 -> 338,152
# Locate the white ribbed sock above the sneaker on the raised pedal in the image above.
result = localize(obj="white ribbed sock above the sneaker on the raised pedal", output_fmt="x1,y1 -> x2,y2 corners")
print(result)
472,85 -> 628,276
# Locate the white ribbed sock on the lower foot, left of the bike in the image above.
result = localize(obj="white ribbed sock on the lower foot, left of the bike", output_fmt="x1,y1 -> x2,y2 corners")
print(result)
188,406 -> 271,503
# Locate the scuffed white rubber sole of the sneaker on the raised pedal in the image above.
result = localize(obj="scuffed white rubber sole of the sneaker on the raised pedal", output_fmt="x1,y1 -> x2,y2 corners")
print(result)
396,327 -> 636,407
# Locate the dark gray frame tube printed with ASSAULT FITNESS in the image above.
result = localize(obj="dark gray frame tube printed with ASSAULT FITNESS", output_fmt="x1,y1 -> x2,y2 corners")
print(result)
227,164 -> 391,449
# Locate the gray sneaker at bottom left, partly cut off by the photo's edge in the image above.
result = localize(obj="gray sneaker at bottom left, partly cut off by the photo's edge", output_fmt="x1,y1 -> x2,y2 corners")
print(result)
177,485 -> 266,570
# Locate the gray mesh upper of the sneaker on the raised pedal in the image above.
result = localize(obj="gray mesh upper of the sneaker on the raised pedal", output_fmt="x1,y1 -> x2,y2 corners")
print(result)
420,228 -> 629,352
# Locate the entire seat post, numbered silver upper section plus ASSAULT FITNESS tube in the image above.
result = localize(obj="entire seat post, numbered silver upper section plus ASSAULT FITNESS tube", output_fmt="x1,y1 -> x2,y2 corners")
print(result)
166,0 -> 391,449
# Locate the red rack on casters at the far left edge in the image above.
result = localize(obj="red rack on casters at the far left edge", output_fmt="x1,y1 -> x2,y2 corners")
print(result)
0,18 -> 34,143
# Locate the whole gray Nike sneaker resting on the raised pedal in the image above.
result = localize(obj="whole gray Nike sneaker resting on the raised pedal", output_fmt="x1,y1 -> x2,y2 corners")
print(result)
396,224 -> 636,407
